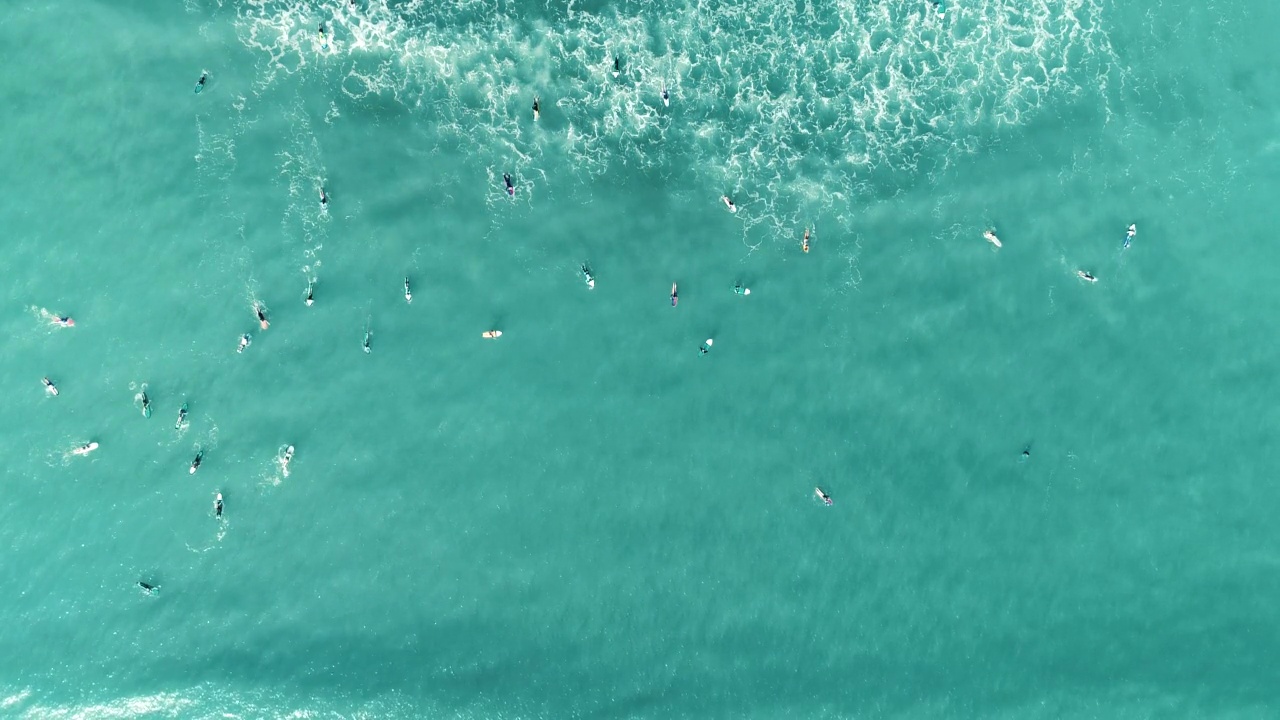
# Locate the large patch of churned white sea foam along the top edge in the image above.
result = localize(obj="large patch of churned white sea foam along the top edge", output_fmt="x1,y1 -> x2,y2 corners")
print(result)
238,0 -> 1117,242
